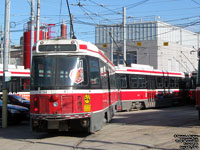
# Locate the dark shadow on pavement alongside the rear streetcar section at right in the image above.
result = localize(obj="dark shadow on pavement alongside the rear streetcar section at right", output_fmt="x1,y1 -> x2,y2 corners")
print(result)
111,105 -> 200,127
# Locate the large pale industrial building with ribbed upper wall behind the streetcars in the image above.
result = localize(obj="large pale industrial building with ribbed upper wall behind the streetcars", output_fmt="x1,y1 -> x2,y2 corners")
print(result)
95,21 -> 199,72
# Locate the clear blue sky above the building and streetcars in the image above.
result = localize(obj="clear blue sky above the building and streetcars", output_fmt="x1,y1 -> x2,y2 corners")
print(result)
0,0 -> 200,44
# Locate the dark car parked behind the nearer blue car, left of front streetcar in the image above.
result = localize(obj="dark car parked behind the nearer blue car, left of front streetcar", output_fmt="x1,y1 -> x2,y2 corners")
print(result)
1,94 -> 30,109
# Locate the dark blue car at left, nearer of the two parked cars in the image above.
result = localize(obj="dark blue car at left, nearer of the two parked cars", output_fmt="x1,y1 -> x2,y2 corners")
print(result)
0,100 -> 30,124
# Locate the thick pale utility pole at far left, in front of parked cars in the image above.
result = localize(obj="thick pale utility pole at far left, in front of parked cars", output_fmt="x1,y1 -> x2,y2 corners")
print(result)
2,0 -> 11,128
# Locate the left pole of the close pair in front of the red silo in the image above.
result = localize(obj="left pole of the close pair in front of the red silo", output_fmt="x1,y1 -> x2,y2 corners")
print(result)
30,0 -> 35,69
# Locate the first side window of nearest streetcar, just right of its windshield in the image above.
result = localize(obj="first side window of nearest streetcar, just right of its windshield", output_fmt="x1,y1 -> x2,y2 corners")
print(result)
89,58 -> 100,87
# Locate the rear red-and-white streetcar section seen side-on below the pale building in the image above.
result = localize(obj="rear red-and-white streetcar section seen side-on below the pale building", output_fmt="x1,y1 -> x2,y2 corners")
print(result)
116,64 -> 185,111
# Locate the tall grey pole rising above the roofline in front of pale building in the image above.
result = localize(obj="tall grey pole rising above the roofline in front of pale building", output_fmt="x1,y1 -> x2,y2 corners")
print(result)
123,7 -> 126,62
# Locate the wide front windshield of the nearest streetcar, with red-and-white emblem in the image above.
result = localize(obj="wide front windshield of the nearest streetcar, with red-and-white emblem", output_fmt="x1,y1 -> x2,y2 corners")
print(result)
31,56 -> 88,90
